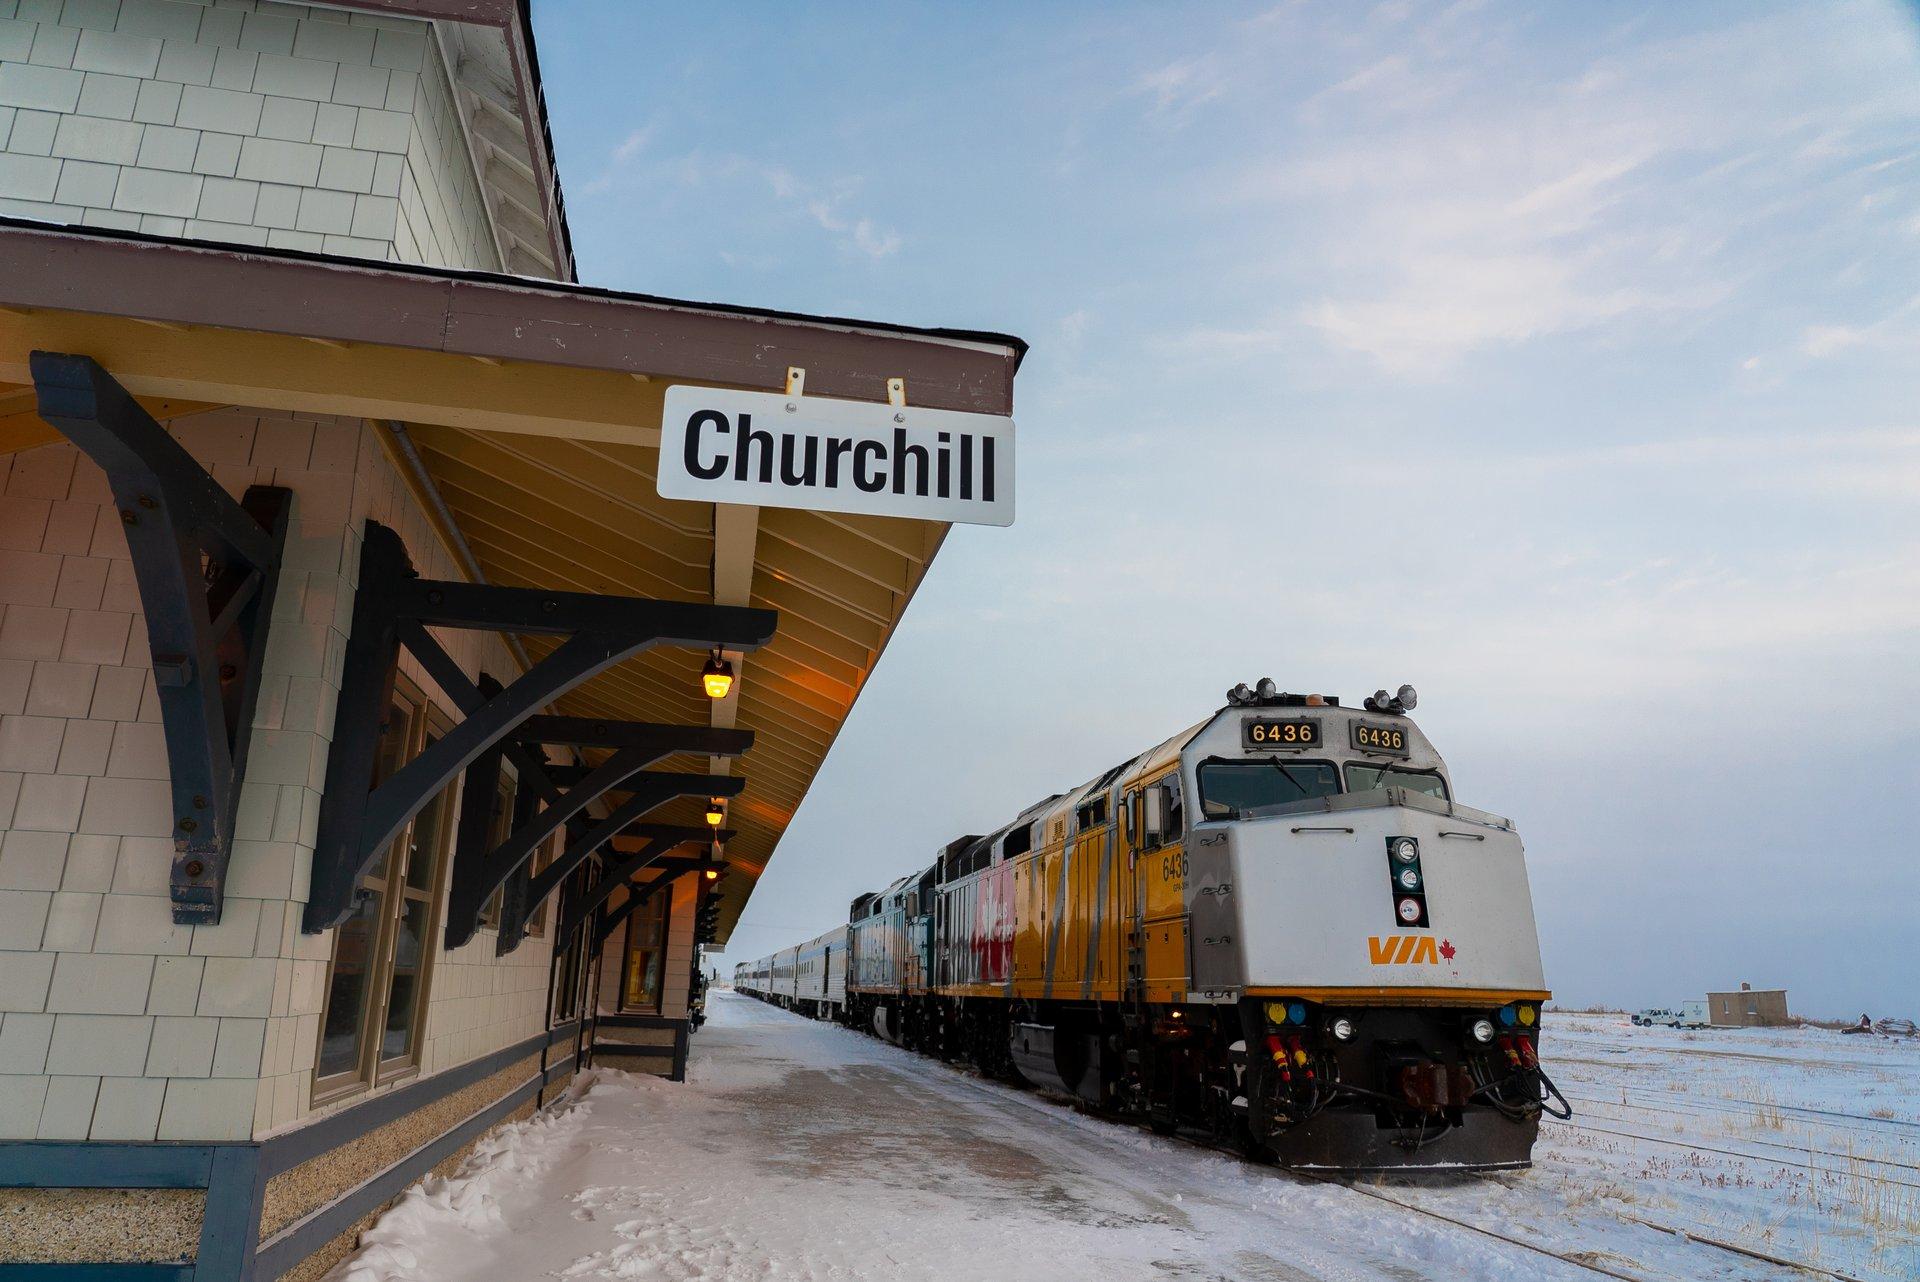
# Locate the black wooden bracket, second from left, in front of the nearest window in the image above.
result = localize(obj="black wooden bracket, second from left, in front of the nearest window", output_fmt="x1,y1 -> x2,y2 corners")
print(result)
301,520 -> 778,933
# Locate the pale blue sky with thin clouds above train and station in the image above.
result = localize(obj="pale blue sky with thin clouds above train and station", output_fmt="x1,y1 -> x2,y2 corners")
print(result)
532,0 -> 1920,1015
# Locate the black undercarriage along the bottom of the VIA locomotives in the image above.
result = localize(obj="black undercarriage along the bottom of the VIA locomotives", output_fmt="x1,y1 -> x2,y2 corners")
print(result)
843,992 -> 1567,1173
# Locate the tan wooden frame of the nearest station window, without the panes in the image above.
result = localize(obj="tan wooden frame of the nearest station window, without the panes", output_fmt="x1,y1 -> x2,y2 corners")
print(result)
311,672 -> 459,1104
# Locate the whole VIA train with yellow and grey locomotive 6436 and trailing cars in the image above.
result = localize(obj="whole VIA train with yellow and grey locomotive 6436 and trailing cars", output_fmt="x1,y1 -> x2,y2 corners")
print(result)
733,679 -> 1567,1171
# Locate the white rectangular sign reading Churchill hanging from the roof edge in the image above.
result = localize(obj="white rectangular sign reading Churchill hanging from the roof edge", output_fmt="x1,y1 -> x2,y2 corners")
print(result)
660,386 -> 1014,526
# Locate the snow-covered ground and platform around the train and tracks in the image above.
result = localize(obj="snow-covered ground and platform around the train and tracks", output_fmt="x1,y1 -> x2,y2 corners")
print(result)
332,992 -> 1920,1282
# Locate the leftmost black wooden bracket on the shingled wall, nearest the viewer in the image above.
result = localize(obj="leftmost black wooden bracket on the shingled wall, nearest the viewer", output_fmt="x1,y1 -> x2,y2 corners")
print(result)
29,351 -> 292,925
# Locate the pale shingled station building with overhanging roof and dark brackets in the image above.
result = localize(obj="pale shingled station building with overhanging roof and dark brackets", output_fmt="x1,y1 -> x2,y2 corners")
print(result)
0,0 -> 1023,1280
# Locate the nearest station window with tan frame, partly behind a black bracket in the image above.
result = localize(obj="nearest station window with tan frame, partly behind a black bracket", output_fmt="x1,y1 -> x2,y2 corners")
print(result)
313,677 -> 453,1096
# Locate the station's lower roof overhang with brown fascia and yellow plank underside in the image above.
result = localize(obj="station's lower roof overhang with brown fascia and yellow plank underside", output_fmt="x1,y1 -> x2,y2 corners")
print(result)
0,221 -> 1025,938
